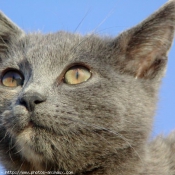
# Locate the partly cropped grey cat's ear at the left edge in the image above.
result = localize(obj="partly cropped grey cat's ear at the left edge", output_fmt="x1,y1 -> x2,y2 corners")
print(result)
0,12 -> 24,58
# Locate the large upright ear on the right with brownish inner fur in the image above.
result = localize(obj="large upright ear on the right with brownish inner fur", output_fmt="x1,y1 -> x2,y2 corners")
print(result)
114,0 -> 175,79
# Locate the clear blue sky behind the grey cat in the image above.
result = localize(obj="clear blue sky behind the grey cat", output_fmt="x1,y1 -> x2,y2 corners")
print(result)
0,0 -> 175,173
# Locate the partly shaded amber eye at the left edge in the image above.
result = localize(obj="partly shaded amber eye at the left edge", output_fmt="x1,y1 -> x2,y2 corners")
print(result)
1,70 -> 24,87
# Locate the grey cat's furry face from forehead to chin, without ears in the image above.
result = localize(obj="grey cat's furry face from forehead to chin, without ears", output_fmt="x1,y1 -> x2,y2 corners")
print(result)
0,32 -> 155,168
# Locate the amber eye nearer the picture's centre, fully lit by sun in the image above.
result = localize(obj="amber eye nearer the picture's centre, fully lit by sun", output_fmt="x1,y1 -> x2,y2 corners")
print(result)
64,66 -> 91,84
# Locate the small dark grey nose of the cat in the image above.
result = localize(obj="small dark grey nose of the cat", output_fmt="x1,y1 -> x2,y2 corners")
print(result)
19,92 -> 46,112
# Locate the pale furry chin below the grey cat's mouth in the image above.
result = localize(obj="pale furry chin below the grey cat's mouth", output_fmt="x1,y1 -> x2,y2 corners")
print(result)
15,121 -> 53,167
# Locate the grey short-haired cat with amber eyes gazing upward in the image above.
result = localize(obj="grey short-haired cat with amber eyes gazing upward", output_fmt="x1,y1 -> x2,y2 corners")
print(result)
0,0 -> 175,175
